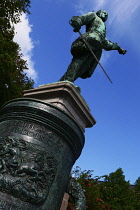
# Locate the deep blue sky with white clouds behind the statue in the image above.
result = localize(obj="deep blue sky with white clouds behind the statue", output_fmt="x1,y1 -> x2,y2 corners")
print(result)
15,0 -> 140,184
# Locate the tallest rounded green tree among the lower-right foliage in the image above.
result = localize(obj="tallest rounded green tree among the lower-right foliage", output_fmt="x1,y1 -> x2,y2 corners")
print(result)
100,168 -> 136,210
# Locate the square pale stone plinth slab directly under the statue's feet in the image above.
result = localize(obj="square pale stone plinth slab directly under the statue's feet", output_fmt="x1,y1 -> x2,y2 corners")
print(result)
24,81 -> 96,129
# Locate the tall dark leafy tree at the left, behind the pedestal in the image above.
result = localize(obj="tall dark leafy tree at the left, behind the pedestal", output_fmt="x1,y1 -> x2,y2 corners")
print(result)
0,0 -> 34,106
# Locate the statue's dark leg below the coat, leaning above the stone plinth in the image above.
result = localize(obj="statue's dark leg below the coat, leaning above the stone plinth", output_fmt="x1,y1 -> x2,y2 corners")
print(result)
59,58 -> 85,82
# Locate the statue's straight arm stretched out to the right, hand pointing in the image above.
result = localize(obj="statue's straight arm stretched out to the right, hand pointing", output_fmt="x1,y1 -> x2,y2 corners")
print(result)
102,39 -> 127,55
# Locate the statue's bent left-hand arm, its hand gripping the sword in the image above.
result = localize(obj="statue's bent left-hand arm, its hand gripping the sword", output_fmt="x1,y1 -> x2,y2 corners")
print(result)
69,12 -> 96,32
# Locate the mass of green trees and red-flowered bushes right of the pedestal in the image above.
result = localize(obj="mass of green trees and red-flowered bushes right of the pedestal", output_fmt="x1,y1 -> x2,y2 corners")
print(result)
69,167 -> 140,210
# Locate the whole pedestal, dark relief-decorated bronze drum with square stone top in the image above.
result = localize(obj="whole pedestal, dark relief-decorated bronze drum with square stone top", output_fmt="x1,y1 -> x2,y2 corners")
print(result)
0,82 -> 95,210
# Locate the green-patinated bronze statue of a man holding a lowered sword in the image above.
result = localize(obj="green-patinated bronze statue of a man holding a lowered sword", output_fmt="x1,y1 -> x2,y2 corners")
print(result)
59,10 -> 127,82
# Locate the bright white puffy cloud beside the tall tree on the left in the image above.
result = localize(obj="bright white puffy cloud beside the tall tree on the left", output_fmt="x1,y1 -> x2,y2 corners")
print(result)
14,14 -> 37,80
